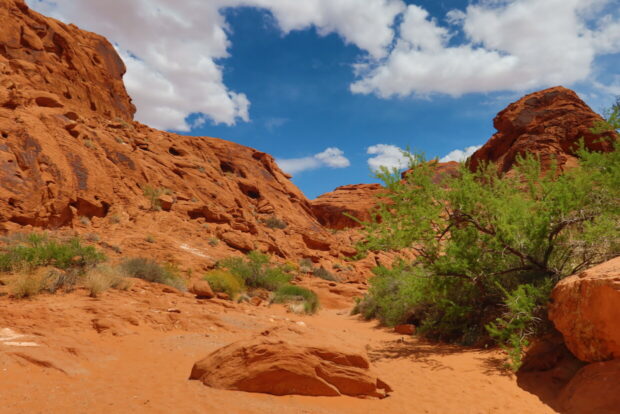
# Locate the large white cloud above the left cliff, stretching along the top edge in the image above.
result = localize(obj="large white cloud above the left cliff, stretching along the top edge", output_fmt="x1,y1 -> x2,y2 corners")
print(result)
28,0 -> 405,131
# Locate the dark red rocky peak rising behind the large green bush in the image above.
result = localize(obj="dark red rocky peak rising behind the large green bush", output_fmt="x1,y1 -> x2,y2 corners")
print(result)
469,87 -> 617,172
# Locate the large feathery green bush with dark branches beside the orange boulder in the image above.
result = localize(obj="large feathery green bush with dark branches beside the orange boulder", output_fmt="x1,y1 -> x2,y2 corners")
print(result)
357,129 -> 620,366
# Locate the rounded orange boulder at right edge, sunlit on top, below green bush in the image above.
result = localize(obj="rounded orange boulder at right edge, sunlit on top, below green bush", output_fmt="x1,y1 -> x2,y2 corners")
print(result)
549,257 -> 620,362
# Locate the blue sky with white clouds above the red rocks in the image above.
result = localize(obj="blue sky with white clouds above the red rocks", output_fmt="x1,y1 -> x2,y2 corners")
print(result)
29,0 -> 620,198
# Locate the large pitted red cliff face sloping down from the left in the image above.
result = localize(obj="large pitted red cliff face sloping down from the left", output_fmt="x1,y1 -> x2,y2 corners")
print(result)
0,0 -> 354,274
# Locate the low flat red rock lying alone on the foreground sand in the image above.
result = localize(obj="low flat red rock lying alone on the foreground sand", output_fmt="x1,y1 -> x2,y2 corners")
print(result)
190,338 -> 391,397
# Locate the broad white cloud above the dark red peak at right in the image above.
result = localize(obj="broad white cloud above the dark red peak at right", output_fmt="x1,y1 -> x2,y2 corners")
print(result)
351,0 -> 620,98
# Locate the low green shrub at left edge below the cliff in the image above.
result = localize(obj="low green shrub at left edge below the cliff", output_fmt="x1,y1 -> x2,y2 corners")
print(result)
0,233 -> 105,273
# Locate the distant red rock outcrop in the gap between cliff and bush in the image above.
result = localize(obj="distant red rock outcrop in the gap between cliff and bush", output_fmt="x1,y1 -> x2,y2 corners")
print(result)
311,184 -> 385,230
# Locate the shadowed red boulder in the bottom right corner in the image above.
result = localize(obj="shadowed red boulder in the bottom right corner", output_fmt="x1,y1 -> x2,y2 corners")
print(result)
559,359 -> 620,414
